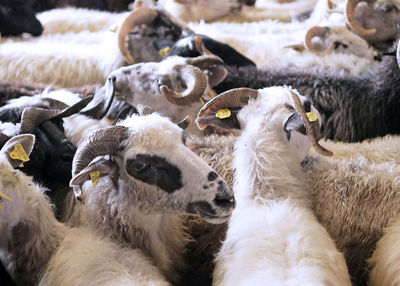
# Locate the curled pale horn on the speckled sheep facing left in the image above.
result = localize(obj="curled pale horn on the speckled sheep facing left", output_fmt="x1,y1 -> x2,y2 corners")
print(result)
160,66 -> 207,105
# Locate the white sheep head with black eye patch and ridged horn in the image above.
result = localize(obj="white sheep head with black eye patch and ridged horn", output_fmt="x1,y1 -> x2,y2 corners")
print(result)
70,113 -> 235,223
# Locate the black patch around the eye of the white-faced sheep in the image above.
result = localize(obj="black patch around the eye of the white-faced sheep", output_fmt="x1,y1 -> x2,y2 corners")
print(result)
126,154 -> 183,193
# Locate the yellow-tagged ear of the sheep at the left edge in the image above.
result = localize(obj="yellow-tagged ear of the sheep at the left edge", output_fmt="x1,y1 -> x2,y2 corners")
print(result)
1,134 -> 35,168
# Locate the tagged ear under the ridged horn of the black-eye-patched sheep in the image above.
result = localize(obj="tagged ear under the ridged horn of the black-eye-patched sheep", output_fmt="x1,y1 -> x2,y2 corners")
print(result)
69,156 -> 118,187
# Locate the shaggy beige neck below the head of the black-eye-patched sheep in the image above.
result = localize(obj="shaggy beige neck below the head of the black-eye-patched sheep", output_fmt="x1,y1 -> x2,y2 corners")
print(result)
84,183 -> 187,283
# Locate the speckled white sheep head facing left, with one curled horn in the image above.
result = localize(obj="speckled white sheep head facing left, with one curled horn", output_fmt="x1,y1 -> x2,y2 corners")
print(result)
108,57 -> 219,122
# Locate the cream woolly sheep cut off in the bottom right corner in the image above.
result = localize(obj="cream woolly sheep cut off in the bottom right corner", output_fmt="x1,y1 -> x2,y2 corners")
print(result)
368,219 -> 400,286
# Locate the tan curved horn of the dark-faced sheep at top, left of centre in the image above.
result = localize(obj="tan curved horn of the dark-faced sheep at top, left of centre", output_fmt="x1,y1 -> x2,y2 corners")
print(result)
118,7 -> 158,65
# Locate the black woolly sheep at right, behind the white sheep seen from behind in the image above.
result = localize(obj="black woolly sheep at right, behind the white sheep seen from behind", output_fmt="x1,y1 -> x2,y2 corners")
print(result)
214,39 -> 400,142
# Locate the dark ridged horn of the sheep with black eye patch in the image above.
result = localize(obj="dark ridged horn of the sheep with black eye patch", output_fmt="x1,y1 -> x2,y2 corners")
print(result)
72,125 -> 128,177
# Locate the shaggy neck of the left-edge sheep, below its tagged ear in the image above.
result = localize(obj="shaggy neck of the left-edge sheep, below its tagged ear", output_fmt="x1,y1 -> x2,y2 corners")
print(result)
0,164 -> 65,285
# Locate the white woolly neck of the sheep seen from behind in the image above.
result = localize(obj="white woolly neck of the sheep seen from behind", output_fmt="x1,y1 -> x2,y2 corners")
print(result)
233,122 -> 311,207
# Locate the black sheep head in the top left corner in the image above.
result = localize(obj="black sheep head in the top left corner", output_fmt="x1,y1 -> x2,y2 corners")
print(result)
0,0 -> 43,37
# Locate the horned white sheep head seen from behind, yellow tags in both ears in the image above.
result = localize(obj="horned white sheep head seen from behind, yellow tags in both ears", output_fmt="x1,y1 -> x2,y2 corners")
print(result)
197,87 -> 332,161
